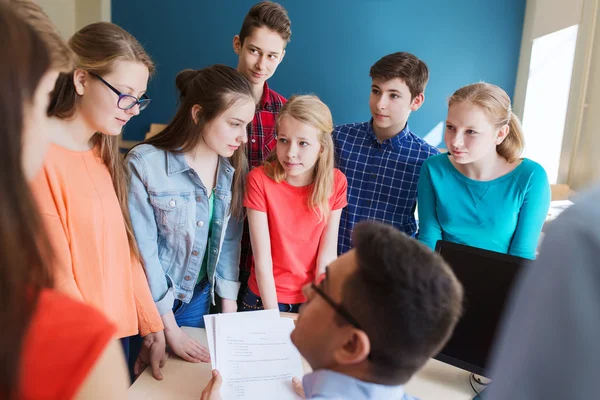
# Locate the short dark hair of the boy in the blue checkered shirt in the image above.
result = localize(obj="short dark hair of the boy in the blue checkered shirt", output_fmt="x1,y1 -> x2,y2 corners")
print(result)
369,51 -> 429,100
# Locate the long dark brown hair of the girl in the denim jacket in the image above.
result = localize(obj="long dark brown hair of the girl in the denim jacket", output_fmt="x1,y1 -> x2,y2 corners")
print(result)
145,64 -> 252,219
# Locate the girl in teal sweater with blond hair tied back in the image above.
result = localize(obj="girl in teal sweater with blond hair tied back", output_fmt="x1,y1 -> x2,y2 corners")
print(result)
418,83 -> 550,259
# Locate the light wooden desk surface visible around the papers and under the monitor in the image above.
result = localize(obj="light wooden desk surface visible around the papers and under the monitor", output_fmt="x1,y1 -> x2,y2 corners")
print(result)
128,313 -> 474,400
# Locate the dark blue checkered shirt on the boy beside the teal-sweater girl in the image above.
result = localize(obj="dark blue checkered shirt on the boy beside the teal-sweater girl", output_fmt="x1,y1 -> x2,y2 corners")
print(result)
333,120 -> 439,254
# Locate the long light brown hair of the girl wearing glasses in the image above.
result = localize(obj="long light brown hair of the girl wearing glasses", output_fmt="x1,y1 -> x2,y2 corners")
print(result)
49,22 -> 154,256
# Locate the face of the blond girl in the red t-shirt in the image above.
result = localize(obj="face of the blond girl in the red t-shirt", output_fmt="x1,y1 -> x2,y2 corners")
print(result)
276,115 -> 322,186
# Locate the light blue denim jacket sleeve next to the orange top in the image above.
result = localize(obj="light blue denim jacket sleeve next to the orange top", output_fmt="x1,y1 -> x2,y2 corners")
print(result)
126,153 -> 175,315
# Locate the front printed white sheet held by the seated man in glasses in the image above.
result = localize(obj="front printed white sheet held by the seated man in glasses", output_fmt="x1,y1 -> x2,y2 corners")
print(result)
216,318 -> 304,400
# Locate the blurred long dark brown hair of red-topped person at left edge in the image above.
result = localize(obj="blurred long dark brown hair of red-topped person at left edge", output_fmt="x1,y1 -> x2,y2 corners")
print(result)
0,4 -> 52,399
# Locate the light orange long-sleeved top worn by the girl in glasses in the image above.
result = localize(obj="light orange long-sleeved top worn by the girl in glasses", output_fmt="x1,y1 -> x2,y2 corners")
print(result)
32,145 -> 163,338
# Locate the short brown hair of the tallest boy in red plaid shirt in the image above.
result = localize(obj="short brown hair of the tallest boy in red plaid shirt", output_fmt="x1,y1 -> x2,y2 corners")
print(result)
239,1 -> 292,45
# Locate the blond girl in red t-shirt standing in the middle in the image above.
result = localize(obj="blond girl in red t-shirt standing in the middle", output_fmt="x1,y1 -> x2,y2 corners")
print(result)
242,95 -> 348,312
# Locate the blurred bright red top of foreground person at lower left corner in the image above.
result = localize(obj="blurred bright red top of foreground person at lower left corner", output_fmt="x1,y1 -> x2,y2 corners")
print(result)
19,289 -> 116,400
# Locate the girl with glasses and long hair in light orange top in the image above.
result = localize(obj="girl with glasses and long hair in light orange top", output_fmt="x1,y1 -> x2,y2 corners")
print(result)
33,22 -> 165,378
